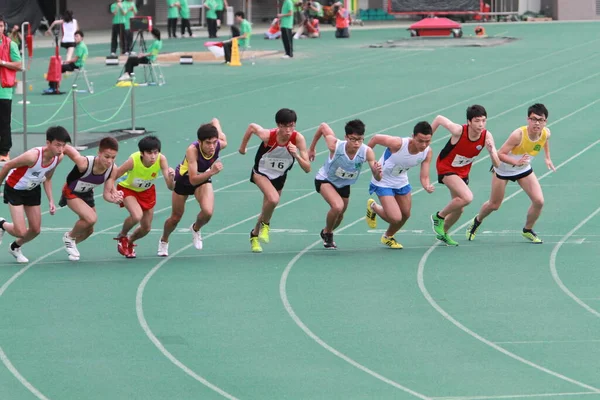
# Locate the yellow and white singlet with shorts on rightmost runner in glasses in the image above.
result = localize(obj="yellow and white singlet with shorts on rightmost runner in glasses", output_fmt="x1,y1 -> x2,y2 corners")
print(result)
494,126 -> 548,182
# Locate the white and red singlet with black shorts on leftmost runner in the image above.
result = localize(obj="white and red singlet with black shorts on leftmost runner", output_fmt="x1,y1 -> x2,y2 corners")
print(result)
4,147 -> 58,207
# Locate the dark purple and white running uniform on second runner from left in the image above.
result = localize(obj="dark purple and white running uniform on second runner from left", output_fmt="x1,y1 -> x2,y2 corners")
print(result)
58,156 -> 114,208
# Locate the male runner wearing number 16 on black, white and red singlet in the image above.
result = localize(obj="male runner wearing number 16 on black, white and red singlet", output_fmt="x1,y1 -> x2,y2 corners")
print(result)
239,108 -> 310,253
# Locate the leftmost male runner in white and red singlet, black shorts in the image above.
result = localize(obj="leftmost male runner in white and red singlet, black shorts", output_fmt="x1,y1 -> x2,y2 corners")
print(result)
0,126 -> 71,263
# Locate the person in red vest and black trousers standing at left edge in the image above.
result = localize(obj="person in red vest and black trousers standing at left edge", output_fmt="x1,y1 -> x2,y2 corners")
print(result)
0,15 -> 21,161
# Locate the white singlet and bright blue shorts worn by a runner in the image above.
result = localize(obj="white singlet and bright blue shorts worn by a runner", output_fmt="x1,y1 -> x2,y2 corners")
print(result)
369,138 -> 431,196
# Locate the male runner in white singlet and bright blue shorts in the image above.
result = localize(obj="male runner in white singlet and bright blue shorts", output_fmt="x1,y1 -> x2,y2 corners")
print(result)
366,121 -> 435,249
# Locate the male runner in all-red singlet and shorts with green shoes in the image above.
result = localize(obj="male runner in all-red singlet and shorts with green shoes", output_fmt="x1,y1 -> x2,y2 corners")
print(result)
431,105 -> 500,246
